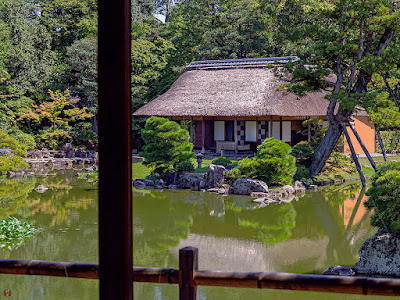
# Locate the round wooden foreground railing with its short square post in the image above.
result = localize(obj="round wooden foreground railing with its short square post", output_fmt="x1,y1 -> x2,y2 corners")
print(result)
0,247 -> 400,300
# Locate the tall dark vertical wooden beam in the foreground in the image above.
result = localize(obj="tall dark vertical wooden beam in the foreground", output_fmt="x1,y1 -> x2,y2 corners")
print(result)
98,0 -> 133,300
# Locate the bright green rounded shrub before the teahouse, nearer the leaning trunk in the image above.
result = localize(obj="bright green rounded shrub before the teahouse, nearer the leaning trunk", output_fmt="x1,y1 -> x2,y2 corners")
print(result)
238,137 -> 296,185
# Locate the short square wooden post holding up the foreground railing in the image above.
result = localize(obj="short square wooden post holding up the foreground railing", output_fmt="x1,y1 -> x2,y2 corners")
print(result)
179,247 -> 199,300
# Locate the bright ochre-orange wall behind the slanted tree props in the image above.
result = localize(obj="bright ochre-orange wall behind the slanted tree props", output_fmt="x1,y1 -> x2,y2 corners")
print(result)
344,116 -> 375,154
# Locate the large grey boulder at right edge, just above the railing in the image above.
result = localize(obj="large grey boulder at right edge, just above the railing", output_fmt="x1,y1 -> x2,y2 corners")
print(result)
356,229 -> 400,276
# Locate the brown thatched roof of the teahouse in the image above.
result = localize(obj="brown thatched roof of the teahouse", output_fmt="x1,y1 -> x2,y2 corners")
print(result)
134,57 -> 366,117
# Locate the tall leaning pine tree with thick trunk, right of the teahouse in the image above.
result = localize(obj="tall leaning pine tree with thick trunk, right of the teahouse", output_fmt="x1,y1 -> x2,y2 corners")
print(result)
276,0 -> 400,175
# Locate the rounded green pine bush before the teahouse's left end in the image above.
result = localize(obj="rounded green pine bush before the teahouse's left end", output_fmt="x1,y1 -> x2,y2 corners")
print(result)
141,117 -> 195,174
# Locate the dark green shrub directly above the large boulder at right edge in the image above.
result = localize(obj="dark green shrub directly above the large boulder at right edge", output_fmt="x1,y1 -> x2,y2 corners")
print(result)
365,162 -> 400,234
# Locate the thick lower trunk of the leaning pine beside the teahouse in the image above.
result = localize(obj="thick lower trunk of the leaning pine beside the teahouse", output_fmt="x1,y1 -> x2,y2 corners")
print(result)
310,123 -> 343,176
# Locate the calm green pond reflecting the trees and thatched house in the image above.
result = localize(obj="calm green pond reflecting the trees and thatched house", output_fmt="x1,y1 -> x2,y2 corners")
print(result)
0,170 -> 390,300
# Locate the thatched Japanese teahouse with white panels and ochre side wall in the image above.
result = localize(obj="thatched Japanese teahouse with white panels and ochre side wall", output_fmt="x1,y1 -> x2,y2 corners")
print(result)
134,57 -> 375,153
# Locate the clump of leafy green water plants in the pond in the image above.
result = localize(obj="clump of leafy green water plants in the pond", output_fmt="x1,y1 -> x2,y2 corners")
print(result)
0,217 -> 40,251
